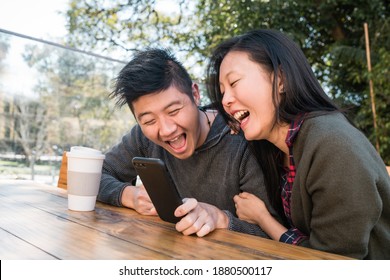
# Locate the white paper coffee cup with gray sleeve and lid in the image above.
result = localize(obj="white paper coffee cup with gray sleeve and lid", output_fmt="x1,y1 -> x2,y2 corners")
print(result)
66,146 -> 105,211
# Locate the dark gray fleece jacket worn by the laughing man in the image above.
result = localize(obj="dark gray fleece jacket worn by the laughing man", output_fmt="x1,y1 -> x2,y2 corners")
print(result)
98,115 -> 279,237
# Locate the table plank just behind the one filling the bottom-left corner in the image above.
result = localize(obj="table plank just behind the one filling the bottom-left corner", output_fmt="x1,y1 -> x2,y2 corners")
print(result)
0,196 -> 169,259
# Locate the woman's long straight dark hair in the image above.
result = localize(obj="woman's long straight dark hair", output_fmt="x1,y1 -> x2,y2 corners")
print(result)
207,29 -> 340,222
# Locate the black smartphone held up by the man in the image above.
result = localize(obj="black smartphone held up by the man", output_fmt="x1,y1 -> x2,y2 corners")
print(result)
132,157 -> 183,223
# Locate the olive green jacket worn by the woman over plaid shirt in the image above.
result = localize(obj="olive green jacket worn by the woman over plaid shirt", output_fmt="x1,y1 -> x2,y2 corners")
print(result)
291,113 -> 390,259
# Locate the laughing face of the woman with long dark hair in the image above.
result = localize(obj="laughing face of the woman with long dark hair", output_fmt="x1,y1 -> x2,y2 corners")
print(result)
219,51 -> 276,142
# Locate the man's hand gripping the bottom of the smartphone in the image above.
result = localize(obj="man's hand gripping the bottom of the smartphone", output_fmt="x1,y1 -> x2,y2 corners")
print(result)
175,198 -> 229,237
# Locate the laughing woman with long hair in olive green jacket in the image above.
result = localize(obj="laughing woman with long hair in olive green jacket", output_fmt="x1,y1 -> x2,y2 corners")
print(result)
208,30 -> 390,259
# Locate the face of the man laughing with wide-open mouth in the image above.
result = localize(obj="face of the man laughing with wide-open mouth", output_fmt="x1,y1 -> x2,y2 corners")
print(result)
132,86 -> 205,159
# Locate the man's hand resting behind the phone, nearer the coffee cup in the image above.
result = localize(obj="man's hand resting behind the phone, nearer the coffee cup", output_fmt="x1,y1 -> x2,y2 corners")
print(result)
122,185 -> 157,216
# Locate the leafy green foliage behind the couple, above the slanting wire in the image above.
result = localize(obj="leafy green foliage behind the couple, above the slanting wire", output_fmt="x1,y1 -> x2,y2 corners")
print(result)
67,0 -> 390,165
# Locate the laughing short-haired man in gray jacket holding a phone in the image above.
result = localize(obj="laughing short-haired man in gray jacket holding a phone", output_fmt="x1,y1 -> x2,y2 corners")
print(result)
98,49 -> 278,237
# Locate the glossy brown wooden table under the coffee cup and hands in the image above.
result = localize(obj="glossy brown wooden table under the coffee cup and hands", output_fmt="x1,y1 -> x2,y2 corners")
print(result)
0,180 -> 352,260
